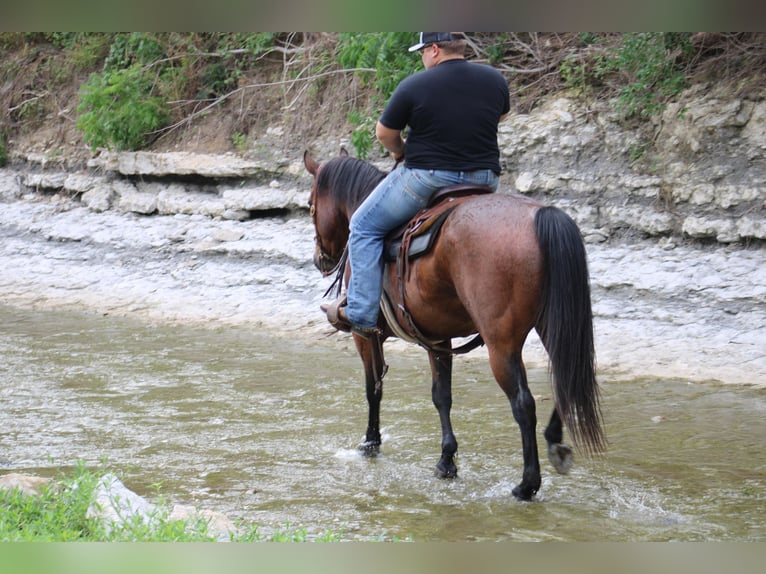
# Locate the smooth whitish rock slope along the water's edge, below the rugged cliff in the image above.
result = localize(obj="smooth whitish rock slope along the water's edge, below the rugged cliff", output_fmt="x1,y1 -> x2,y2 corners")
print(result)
0,156 -> 766,392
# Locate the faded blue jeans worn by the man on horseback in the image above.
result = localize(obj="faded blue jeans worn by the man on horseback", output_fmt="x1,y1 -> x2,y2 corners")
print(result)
346,167 -> 499,328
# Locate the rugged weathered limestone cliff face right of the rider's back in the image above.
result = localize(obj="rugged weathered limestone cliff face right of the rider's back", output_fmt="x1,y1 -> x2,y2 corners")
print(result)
500,86 -> 766,243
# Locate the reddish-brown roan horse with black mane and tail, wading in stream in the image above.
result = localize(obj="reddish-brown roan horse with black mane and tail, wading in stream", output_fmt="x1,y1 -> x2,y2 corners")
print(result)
303,150 -> 606,500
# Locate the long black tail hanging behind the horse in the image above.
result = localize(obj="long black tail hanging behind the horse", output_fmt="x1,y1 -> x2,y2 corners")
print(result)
535,207 -> 606,452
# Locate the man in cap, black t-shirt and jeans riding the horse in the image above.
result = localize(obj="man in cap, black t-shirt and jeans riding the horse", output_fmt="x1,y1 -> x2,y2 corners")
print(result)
323,32 -> 510,336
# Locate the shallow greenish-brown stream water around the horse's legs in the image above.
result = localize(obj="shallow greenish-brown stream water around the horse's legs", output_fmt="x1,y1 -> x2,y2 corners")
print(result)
0,306 -> 766,541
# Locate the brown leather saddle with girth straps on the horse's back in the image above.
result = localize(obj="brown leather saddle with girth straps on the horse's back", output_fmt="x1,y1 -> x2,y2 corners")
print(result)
380,184 -> 494,353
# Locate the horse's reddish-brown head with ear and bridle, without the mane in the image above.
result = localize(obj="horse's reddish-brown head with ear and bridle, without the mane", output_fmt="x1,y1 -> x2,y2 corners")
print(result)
303,150 -> 349,276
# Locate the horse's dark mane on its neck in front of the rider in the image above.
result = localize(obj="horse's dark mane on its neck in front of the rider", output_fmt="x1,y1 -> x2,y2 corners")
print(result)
317,156 -> 386,212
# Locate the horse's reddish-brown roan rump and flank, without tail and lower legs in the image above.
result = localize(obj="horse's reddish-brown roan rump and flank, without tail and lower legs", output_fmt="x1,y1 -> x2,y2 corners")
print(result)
388,194 -> 542,345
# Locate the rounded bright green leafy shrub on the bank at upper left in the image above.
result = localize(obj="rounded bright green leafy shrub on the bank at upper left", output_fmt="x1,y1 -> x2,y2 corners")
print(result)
77,64 -> 168,150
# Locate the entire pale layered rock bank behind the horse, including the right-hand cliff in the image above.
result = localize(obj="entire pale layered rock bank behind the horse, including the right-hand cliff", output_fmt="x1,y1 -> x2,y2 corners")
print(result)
0,86 -> 766,385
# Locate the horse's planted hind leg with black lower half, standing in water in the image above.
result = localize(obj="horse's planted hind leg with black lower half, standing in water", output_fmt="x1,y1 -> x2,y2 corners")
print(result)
490,349 -> 541,500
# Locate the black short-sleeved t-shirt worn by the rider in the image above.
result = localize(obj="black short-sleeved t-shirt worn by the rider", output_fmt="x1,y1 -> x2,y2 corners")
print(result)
380,59 -> 510,174
